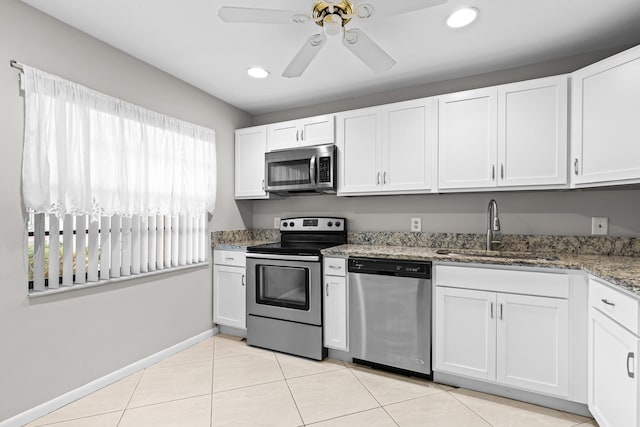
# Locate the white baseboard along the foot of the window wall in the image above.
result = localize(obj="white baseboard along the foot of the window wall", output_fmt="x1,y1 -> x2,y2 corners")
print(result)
0,327 -> 219,427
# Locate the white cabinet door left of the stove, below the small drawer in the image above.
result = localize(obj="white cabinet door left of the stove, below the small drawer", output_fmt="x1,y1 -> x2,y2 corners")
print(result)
213,265 -> 247,329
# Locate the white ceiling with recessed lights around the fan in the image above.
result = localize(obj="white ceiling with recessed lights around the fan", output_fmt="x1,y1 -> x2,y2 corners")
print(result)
23,0 -> 640,114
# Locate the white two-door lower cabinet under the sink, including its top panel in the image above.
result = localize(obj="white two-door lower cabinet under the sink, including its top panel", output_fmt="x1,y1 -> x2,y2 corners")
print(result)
434,267 -> 569,397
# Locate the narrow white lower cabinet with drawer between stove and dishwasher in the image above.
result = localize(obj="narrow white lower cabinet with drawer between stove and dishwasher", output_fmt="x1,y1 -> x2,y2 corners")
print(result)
323,258 -> 349,351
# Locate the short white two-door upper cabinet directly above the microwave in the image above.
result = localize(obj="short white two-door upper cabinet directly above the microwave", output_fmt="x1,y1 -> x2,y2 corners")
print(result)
267,114 -> 335,151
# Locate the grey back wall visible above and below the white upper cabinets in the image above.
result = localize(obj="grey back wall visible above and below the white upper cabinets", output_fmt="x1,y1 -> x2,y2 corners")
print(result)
253,45 -> 640,236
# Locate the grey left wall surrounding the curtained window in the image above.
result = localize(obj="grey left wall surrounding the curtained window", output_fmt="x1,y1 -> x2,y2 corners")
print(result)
0,0 -> 251,421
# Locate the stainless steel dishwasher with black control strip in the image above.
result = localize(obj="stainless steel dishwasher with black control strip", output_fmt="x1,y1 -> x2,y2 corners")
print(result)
349,258 -> 432,379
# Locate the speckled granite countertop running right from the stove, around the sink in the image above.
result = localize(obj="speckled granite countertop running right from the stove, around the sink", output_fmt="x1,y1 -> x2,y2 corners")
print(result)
322,244 -> 640,298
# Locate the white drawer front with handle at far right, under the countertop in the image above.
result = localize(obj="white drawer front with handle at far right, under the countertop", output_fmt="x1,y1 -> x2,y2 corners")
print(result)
589,277 -> 640,335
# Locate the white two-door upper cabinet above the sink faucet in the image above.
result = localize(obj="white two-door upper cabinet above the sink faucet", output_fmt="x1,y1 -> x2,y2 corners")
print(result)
438,76 -> 568,190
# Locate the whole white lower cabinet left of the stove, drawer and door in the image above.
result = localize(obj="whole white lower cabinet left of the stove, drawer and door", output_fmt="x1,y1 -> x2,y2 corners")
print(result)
213,250 -> 247,329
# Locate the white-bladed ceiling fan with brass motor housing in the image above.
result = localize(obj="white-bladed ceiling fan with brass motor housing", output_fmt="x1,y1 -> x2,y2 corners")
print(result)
218,0 -> 447,77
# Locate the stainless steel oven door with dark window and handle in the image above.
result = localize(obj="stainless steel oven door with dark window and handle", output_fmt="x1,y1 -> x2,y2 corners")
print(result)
247,253 -> 322,326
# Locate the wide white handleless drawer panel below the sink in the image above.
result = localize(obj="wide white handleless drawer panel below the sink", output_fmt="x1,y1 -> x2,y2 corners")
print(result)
434,265 -> 569,299
